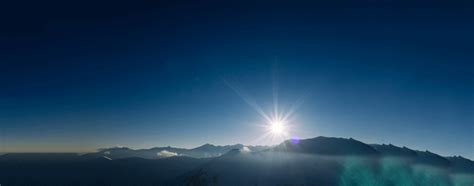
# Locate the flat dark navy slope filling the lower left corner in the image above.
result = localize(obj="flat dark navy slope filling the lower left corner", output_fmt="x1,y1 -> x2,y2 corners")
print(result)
0,154 -> 208,186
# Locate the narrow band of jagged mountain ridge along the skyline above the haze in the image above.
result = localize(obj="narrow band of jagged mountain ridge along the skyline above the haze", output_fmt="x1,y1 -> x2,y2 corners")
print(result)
0,136 -> 473,162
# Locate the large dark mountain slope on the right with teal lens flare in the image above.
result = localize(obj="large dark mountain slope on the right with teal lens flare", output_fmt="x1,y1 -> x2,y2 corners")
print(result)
175,137 -> 474,186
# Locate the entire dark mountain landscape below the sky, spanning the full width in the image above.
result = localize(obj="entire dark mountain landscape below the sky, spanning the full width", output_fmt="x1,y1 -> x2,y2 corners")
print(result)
0,137 -> 474,186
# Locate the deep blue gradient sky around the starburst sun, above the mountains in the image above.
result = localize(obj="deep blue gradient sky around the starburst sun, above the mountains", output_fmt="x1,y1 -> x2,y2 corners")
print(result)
0,0 -> 474,159
